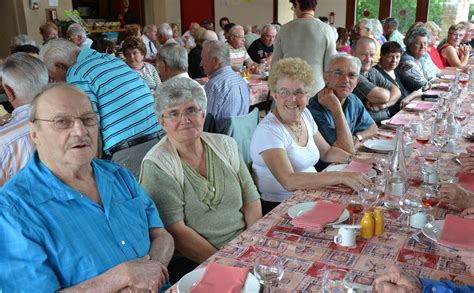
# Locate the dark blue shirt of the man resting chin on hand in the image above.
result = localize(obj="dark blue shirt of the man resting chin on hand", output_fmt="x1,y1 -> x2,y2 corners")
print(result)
308,94 -> 374,145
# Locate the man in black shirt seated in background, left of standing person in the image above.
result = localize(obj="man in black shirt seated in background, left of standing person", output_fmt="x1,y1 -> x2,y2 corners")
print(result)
247,24 -> 277,63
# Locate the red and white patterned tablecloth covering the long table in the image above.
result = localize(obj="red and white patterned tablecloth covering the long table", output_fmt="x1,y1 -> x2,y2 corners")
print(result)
171,74 -> 474,292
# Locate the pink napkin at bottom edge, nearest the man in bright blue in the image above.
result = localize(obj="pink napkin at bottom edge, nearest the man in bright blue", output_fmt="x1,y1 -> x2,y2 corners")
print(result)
190,262 -> 249,293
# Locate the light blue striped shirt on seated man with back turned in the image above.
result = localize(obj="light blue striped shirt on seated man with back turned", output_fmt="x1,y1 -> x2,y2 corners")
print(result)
204,66 -> 250,131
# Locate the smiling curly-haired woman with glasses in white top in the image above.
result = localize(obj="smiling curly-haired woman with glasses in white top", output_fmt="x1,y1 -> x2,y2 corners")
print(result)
250,58 -> 370,213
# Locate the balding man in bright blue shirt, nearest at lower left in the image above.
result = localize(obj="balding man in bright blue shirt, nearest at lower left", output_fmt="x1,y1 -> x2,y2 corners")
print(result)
0,83 -> 174,292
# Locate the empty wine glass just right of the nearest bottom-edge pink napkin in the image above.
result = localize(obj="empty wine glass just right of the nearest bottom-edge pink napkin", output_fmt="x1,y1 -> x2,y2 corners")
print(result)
254,254 -> 284,293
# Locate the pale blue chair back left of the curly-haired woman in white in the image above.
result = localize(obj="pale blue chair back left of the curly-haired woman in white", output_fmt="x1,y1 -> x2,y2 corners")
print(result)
224,108 -> 260,164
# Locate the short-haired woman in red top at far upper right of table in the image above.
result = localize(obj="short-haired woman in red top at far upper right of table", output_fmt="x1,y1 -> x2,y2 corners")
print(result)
438,23 -> 471,68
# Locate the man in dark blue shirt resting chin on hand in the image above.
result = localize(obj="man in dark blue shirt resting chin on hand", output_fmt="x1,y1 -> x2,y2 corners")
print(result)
308,53 -> 378,154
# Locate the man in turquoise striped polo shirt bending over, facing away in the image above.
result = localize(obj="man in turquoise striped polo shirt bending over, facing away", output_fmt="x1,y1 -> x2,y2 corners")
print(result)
40,39 -> 163,167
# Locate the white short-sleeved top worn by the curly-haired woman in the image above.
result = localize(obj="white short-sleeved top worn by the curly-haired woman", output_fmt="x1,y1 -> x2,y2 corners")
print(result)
250,109 -> 319,202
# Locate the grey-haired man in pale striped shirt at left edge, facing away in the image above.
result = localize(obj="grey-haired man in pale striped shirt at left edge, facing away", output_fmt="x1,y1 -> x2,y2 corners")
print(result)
0,53 -> 48,187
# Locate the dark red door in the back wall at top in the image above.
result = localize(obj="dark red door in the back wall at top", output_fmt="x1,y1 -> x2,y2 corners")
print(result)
181,0 -> 216,33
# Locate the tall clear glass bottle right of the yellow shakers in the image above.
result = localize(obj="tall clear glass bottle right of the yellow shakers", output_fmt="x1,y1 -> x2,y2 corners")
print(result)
385,126 -> 408,209
